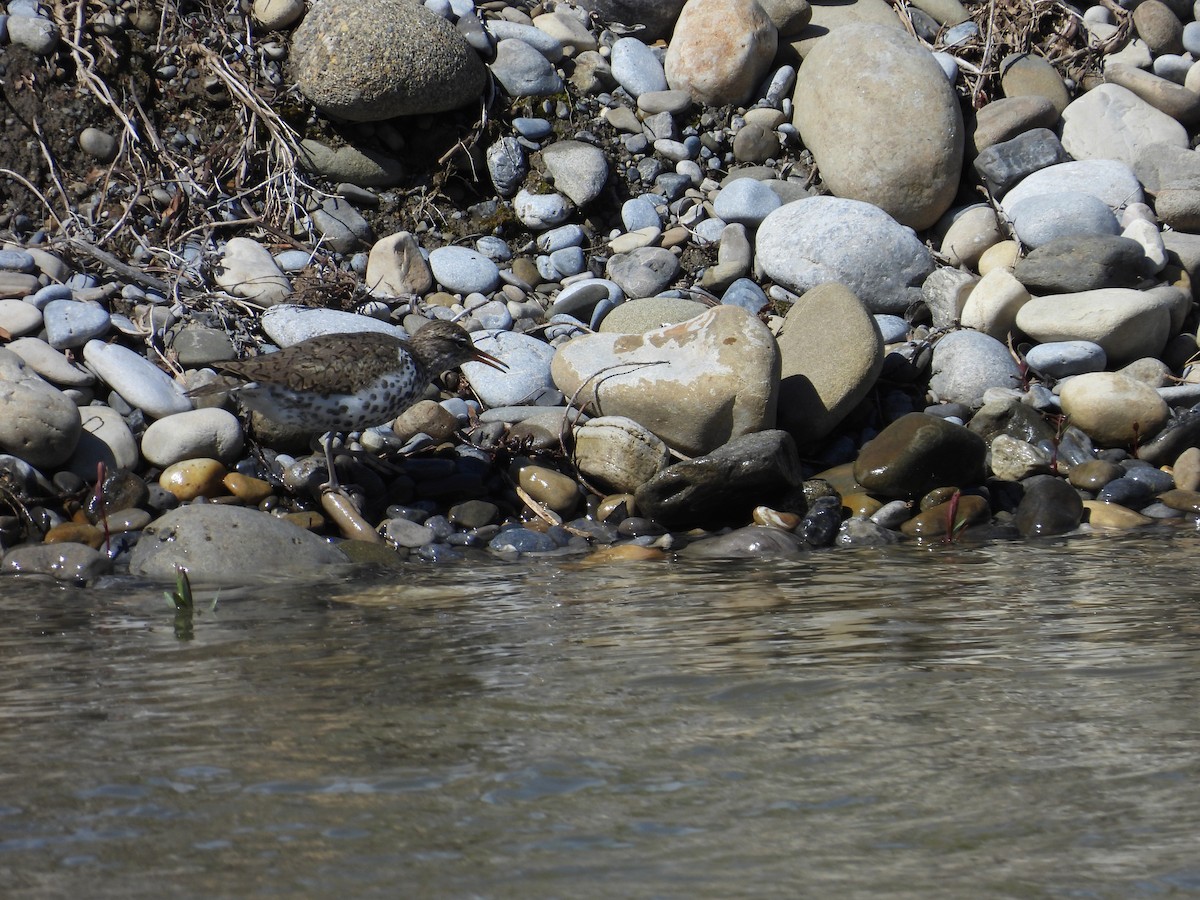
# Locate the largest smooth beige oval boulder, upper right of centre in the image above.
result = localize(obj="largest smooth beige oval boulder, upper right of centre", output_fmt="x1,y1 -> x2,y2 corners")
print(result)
793,25 -> 964,229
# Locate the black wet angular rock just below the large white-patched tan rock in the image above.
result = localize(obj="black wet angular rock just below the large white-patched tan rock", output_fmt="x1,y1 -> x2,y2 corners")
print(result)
638,431 -> 805,528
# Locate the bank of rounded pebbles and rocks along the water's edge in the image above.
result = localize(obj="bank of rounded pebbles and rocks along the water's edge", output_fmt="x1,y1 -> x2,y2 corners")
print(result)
0,0 -> 1200,581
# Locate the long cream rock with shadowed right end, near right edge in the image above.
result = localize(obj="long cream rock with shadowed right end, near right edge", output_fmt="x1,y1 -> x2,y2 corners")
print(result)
1016,288 -> 1174,366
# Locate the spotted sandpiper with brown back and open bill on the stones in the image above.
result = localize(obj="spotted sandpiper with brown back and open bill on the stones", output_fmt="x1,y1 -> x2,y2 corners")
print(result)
188,320 -> 506,490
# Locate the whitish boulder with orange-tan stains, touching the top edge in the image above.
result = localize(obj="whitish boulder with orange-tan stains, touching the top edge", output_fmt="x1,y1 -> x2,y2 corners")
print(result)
665,0 -> 779,106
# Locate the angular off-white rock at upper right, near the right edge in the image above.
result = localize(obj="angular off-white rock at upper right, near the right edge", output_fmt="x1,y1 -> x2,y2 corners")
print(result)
1062,84 -> 1188,167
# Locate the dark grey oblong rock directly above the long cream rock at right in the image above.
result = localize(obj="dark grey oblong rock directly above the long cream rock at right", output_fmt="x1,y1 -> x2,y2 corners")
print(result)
1013,234 -> 1146,294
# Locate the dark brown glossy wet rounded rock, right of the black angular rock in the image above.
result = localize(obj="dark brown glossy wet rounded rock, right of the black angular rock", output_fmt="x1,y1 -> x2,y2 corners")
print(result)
854,413 -> 988,498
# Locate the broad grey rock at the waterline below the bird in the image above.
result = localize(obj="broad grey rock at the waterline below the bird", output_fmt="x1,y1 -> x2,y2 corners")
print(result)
130,504 -> 347,582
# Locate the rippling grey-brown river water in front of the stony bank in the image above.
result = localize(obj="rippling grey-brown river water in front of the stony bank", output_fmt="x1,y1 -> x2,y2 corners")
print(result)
0,530 -> 1200,900
